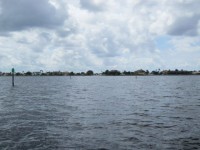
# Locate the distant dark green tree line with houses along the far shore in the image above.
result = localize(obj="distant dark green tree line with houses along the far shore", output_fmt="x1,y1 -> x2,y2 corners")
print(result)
0,69 -> 200,76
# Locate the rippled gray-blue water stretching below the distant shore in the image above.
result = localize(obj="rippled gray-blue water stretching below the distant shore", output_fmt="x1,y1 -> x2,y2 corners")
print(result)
0,76 -> 200,150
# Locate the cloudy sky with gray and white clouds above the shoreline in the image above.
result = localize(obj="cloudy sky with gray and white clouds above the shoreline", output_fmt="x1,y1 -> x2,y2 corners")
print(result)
0,0 -> 200,72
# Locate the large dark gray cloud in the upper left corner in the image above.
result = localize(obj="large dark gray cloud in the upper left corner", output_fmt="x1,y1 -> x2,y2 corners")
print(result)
0,0 -> 65,32
